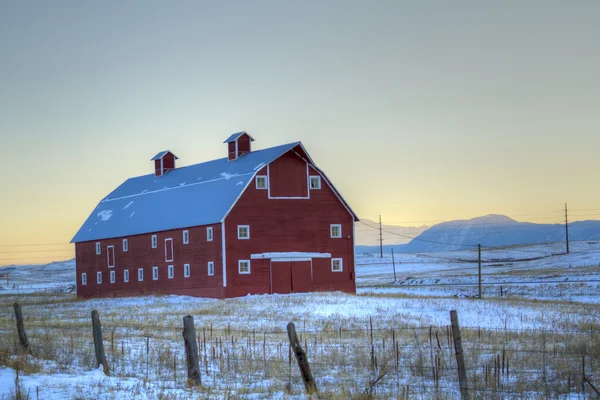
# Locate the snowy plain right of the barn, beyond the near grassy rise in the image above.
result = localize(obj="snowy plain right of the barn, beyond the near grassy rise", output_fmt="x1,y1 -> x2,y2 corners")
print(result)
356,241 -> 600,303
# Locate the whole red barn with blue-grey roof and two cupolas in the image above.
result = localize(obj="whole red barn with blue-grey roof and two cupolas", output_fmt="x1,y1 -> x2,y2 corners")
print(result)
72,132 -> 358,298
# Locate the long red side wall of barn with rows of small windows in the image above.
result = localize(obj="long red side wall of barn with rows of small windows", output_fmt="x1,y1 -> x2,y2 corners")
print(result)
75,224 -> 223,297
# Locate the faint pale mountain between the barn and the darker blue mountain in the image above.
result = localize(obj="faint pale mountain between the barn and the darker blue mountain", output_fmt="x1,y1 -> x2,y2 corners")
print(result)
354,219 -> 429,246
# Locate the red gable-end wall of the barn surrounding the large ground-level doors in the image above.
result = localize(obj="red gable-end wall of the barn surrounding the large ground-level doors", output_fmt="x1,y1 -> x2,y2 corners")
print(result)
225,160 -> 356,297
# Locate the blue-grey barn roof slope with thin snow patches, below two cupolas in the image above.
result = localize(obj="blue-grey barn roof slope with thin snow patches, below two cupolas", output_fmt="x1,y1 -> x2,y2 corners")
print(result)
71,142 -> 300,243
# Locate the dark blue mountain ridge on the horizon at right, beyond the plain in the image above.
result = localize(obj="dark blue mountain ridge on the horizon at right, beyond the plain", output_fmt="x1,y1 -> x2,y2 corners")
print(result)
356,214 -> 600,253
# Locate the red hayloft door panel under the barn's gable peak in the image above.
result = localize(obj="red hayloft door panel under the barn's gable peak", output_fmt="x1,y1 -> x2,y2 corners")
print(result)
268,152 -> 308,197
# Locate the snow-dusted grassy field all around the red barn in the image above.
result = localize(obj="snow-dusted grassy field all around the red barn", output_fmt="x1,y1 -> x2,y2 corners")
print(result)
0,242 -> 600,399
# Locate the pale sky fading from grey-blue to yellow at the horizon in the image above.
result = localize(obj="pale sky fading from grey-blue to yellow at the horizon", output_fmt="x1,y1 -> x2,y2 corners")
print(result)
0,0 -> 600,265
